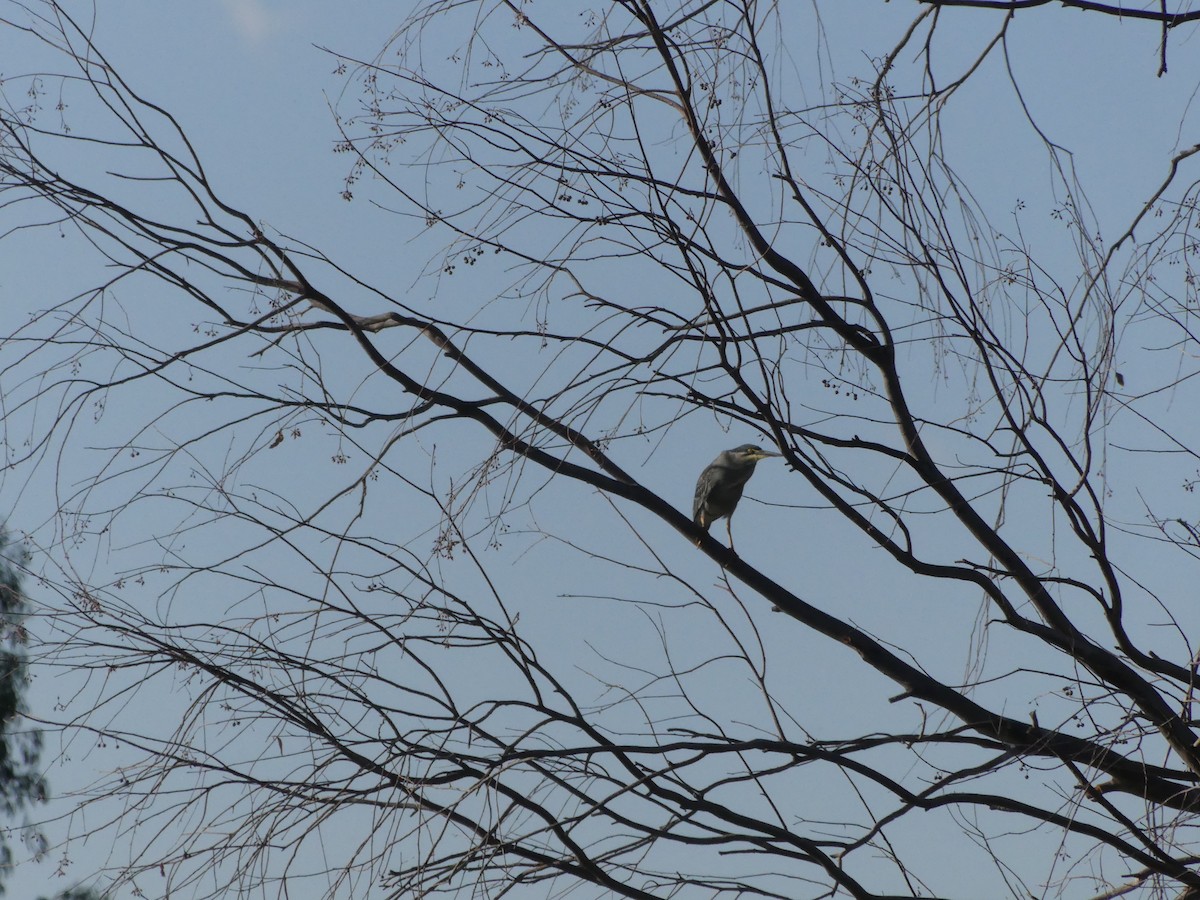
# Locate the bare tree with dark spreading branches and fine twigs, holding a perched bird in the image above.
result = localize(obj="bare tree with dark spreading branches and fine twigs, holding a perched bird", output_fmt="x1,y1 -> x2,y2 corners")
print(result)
0,0 -> 1200,898
